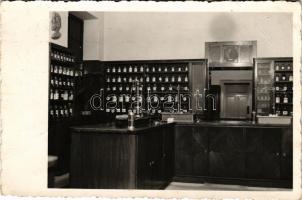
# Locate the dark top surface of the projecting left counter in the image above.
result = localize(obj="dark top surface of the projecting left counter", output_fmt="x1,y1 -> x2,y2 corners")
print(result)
71,122 -> 175,134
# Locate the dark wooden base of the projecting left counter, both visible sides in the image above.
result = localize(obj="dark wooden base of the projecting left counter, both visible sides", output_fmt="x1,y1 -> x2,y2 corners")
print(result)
70,124 -> 174,189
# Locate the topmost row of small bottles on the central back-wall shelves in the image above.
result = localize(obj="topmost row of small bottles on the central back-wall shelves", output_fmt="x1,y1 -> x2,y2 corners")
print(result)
106,65 -> 188,73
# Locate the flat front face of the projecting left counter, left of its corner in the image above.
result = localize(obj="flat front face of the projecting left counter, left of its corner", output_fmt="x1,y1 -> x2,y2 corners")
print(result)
71,133 -> 135,189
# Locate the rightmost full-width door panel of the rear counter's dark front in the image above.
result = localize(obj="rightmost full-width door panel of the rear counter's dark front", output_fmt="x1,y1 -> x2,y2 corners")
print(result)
246,127 -> 282,179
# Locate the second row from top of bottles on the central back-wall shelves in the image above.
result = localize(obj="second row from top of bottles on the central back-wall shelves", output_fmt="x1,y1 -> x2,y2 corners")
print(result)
106,75 -> 189,83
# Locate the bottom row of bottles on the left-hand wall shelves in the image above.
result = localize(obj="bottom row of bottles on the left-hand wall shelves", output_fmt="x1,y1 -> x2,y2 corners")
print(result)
49,104 -> 73,120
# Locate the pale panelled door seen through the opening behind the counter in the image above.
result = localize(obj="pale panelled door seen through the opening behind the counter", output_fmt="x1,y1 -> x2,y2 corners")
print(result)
225,94 -> 249,119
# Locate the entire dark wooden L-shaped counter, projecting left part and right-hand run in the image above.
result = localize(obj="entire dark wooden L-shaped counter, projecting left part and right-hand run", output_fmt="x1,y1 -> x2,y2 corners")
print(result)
70,121 -> 293,189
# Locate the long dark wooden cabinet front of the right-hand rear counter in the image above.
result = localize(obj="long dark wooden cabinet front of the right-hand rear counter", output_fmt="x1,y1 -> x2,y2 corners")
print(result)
175,125 -> 292,187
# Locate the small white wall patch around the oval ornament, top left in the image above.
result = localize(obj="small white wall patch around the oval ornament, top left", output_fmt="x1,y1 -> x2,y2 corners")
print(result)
49,12 -> 68,47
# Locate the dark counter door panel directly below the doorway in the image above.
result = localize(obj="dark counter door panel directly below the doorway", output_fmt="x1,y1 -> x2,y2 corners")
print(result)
209,127 -> 245,178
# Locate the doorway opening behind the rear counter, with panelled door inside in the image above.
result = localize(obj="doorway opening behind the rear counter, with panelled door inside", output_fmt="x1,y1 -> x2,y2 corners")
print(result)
221,80 -> 252,119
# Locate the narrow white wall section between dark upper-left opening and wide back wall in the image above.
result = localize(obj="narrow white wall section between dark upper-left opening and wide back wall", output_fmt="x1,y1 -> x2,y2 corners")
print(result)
83,12 -> 104,60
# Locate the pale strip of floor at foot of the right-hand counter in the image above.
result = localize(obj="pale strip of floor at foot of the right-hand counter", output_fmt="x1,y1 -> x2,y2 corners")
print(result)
166,182 -> 289,191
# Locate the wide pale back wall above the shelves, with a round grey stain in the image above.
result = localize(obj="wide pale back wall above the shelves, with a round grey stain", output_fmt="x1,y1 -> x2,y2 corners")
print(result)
104,12 -> 293,60
